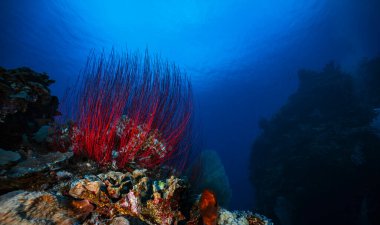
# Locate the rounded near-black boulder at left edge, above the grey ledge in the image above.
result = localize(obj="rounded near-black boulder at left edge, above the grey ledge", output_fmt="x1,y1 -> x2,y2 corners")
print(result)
0,67 -> 58,149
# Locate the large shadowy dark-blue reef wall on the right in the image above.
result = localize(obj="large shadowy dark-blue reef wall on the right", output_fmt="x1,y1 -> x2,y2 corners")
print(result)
251,58 -> 380,225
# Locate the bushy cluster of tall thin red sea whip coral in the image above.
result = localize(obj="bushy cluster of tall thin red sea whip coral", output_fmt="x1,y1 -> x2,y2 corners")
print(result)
62,52 -> 192,171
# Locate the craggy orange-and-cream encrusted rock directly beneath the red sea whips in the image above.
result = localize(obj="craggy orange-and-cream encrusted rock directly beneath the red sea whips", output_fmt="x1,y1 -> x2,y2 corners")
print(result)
69,170 -> 186,225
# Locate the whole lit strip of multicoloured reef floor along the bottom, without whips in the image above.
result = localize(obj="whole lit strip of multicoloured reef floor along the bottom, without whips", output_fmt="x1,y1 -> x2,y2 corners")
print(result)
0,170 -> 272,225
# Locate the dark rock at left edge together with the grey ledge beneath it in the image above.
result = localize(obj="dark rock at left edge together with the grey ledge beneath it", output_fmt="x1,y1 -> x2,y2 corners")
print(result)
0,67 -> 65,194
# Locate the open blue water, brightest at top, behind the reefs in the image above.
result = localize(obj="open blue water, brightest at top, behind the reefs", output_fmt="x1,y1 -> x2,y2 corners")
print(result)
0,0 -> 380,209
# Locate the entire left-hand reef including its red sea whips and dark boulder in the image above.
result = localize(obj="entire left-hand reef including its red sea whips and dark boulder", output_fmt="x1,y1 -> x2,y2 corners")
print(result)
0,63 -> 271,225
